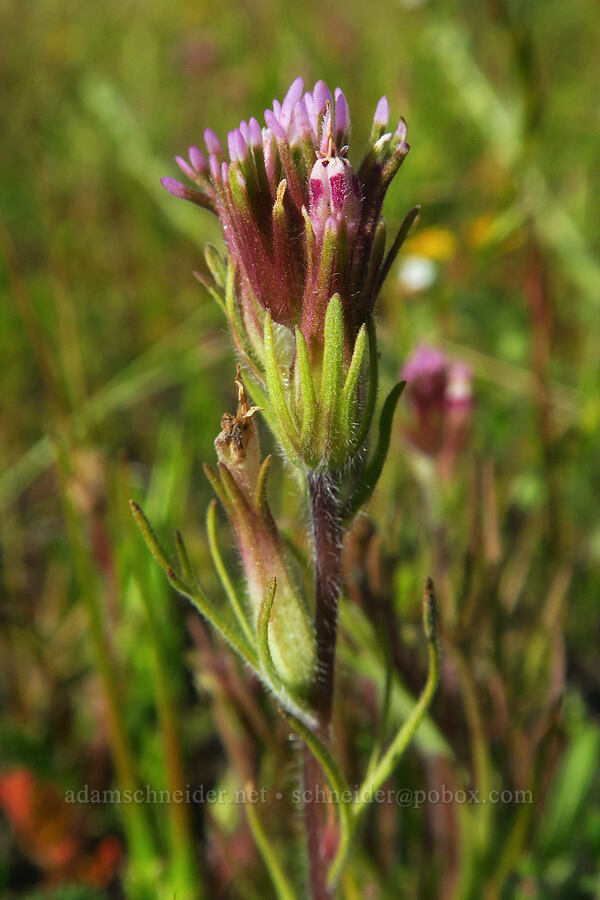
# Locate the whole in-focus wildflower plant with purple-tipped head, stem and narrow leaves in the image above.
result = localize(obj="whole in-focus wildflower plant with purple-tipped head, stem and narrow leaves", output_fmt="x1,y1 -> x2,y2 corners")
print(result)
133,78 -> 438,897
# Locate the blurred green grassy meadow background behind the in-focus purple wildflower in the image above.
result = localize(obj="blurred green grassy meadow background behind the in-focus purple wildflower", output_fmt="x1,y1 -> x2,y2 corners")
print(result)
0,0 -> 600,900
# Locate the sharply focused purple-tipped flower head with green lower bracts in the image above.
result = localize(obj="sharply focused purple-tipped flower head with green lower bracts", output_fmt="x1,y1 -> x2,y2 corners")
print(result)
163,78 -> 416,471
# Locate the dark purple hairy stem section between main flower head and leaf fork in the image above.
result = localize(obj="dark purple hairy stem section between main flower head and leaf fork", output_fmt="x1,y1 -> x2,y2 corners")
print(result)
308,473 -> 342,737
